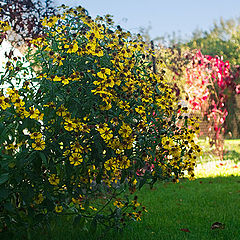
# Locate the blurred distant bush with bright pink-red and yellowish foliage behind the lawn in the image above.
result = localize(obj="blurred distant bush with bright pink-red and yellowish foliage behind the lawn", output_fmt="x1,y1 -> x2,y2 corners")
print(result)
157,46 -> 240,159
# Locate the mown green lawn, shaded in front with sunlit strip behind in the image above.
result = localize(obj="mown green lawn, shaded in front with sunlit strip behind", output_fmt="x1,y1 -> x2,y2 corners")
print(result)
0,140 -> 240,240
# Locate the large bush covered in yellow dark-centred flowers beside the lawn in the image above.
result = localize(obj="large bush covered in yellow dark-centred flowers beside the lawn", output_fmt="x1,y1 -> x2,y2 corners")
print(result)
0,7 -> 200,233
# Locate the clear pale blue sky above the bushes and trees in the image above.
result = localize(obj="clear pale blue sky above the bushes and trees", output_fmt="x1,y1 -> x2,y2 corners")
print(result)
54,0 -> 240,39
